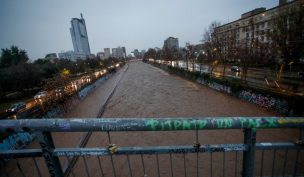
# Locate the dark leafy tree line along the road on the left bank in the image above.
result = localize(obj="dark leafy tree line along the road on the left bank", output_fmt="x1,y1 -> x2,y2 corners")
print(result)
0,46 -> 122,100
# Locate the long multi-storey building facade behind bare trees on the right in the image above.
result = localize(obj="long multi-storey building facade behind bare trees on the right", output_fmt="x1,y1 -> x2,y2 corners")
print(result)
212,0 -> 304,60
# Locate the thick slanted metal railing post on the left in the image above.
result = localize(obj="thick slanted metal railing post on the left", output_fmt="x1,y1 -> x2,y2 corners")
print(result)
35,132 -> 63,177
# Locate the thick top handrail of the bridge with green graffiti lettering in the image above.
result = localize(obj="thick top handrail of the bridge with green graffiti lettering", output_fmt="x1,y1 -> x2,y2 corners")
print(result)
0,117 -> 304,132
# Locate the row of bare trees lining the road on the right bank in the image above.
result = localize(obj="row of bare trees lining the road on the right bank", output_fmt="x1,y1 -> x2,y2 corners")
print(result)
144,1 -> 304,80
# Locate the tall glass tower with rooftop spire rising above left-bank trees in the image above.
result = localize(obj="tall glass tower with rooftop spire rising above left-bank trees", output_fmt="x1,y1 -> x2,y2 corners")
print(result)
70,14 -> 91,57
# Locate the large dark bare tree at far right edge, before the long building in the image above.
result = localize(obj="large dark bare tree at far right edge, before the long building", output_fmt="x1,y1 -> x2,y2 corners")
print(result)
268,0 -> 304,64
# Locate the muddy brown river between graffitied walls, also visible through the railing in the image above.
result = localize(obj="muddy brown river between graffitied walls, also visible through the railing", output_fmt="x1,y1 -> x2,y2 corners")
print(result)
1,61 -> 304,177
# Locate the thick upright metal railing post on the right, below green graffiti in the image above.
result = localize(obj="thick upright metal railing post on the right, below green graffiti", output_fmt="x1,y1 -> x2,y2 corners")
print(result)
242,128 -> 256,177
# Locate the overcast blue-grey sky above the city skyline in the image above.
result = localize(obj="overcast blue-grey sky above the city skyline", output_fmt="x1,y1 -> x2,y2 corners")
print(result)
0,0 -> 278,60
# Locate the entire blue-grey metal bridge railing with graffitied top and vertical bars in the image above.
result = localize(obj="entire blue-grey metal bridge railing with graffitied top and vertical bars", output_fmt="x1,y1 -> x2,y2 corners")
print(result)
0,117 -> 304,177
